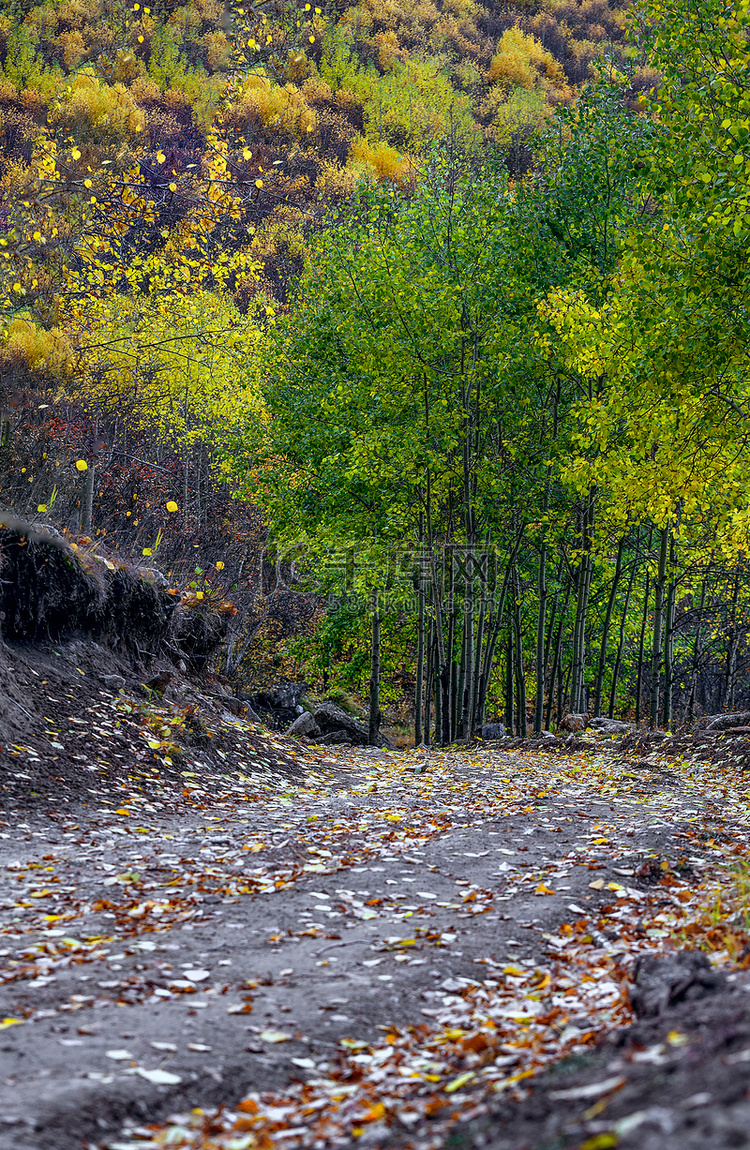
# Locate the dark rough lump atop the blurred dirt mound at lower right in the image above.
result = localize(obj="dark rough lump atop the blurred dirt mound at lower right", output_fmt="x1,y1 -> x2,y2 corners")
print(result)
630,950 -> 726,1018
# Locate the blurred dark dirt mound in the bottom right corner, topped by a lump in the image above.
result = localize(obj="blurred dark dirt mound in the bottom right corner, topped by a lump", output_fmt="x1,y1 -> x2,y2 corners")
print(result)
446,951 -> 750,1150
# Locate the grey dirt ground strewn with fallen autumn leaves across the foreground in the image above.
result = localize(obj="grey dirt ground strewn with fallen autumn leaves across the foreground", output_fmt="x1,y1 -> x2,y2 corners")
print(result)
0,672 -> 750,1150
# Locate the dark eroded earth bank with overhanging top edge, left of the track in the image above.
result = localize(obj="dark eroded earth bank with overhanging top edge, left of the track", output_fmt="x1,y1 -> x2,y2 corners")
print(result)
0,516 -> 298,817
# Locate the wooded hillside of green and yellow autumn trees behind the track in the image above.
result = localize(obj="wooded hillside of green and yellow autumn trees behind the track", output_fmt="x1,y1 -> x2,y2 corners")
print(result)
0,0 -> 750,741
